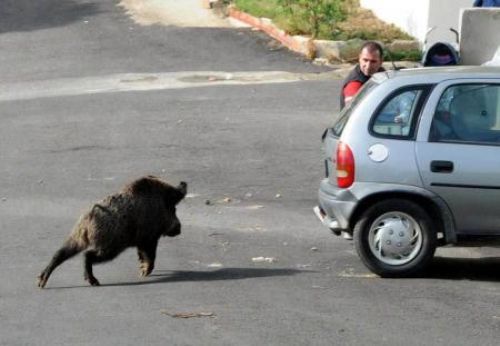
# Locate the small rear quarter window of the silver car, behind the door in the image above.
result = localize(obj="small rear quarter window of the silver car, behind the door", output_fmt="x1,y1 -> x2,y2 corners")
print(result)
371,87 -> 424,138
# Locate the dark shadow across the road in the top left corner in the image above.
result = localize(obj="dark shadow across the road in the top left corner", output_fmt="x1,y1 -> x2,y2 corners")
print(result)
0,0 -> 101,33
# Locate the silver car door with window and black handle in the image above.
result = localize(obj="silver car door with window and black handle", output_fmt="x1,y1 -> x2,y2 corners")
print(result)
416,79 -> 500,235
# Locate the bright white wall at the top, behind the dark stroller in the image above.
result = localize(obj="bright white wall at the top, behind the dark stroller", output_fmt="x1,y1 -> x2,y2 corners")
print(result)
360,0 -> 473,44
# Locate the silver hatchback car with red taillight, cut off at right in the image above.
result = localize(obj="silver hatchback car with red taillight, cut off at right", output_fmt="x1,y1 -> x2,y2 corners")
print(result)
315,66 -> 500,277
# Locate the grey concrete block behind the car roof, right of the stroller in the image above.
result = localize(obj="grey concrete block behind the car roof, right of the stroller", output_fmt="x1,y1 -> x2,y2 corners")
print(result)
460,8 -> 500,65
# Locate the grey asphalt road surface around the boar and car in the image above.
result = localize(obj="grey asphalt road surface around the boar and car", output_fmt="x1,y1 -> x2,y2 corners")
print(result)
0,0 -> 500,345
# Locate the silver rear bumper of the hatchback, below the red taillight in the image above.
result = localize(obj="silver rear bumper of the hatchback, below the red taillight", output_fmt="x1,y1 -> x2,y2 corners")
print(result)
314,179 -> 358,235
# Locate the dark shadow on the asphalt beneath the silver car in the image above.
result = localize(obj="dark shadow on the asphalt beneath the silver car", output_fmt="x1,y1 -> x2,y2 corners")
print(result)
425,257 -> 500,282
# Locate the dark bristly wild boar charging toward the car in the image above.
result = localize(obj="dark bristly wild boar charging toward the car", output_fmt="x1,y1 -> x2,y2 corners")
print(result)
38,176 -> 187,288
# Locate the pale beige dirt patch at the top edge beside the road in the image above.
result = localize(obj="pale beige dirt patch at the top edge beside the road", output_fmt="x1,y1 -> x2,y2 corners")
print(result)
120,0 -> 229,28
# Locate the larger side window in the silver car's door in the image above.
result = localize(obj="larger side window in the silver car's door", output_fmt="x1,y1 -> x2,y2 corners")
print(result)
429,84 -> 500,145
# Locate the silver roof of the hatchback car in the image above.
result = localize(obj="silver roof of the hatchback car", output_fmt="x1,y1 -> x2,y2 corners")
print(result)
372,66 -> 500,83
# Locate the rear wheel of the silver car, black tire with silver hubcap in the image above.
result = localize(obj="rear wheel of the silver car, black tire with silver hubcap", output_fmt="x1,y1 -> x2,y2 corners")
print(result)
354,199 -> 437,277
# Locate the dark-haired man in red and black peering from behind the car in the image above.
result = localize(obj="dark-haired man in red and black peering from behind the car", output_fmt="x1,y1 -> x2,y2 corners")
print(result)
340,41 -> 385,109
